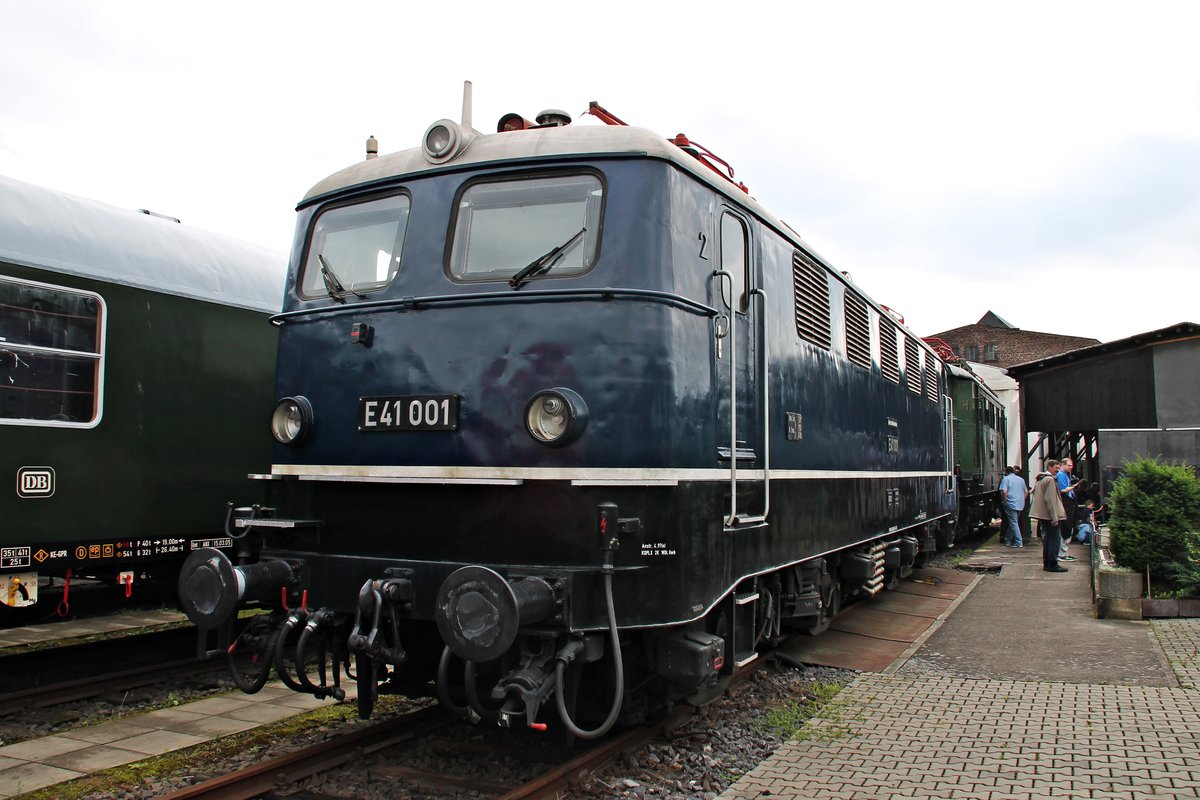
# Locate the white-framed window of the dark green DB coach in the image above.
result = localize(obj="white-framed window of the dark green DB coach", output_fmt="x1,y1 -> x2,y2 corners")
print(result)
0,277 -> 104,428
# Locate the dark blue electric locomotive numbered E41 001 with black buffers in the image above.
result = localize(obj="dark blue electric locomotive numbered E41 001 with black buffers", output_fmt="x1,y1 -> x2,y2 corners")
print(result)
180,90 -> 955,736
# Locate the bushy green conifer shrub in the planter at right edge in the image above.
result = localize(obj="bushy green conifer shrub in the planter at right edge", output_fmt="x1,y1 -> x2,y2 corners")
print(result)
1109,458 -> 1200,582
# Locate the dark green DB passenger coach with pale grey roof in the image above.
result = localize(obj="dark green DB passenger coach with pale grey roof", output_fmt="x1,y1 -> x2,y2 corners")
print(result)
0,178 -> 286,622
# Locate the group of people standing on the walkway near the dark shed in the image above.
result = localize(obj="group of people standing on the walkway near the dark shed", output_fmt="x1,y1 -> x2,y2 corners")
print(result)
1000,458 -> 1096,572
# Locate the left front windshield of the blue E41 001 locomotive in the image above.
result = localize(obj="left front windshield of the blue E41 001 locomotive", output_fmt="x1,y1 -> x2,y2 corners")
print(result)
300,194 -> 410,301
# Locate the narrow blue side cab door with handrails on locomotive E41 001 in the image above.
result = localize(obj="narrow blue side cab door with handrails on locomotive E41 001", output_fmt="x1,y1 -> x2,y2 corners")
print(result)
714,210 -> 769,528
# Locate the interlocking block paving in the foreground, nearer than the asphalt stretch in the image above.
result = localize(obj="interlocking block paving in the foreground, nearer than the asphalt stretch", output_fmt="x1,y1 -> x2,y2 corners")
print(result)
722,673 -> 1200,800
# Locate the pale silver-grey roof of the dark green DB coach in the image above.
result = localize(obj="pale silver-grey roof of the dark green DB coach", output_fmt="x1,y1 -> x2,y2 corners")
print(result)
0,176 -> 287,312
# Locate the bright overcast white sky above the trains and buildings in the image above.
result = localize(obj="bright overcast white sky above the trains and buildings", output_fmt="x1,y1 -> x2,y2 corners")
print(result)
0,0 -> 1200,341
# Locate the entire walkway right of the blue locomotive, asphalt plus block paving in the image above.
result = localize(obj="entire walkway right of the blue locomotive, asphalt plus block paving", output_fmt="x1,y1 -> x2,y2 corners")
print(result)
721,542 -> 1200,800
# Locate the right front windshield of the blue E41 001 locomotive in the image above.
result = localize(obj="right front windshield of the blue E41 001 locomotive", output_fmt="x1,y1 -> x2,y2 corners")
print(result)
449,175 -> 604,281
